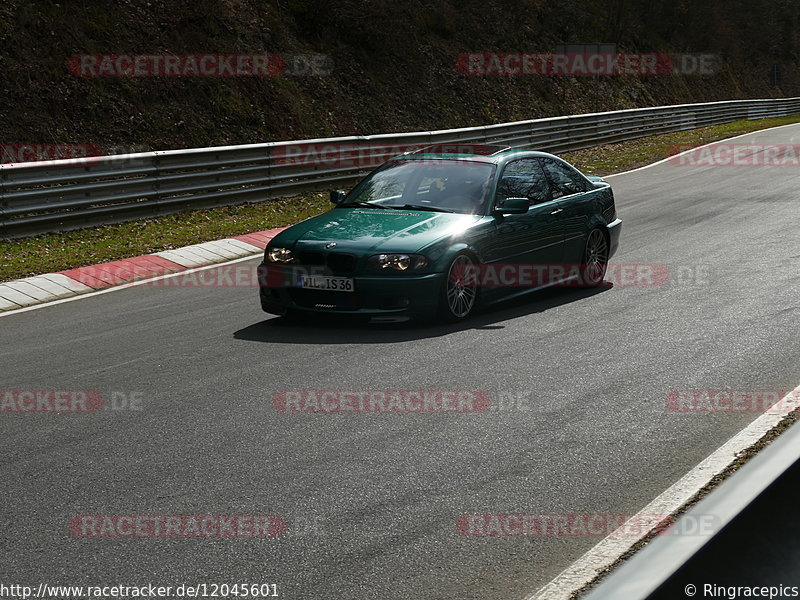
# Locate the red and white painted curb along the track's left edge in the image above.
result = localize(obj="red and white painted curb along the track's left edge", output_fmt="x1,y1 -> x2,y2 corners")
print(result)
0,227 -> 284,312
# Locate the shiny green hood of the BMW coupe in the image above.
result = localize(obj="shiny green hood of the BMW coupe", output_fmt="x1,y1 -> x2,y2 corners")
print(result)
270,208 -> 482,252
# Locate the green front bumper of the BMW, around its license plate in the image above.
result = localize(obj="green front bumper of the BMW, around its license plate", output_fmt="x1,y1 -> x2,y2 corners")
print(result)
259,263 -> 444,320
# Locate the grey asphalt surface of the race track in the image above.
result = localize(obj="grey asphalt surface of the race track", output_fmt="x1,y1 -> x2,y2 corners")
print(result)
0,126 -> 800,600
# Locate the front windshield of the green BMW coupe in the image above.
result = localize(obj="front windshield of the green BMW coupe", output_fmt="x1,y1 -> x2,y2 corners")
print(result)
342,159 -> 494,214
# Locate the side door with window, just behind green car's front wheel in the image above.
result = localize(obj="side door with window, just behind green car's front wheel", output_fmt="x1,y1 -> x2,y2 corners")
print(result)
488,158 -> 564,284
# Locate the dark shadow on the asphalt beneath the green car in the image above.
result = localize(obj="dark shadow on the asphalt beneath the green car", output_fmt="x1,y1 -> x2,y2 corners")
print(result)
233,283 -> 614,344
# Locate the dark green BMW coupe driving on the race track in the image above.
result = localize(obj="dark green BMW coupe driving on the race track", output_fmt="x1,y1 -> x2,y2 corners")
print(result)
259,145 -> 622,321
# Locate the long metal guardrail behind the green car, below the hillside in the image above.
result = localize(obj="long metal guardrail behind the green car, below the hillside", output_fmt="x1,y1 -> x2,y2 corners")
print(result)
0,98 -> 800,238
